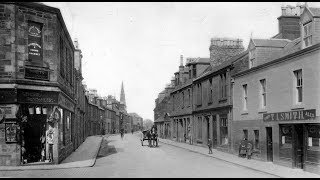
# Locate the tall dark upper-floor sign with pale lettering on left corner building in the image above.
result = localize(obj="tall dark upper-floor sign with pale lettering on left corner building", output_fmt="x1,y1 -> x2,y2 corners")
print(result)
28,21 -> 42,64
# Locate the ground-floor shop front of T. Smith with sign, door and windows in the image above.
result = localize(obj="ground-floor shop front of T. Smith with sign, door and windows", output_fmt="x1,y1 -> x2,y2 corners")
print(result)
263,109 -> 320,174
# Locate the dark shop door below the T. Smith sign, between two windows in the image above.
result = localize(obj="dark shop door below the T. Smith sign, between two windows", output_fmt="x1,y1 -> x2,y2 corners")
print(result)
293,124 -> 304,169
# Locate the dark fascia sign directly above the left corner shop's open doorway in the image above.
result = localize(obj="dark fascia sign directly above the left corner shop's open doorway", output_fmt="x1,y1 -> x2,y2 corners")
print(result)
18,89 -> 58,104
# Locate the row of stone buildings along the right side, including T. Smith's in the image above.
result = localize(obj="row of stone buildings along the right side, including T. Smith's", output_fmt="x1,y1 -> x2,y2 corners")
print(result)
154,3 -> 320,173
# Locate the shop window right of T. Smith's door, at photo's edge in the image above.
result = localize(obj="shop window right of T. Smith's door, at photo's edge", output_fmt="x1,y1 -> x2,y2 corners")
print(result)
308,125 -> 320,151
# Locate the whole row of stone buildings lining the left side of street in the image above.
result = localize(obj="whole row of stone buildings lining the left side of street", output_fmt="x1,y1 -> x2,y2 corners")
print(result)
0,2 -> 142,166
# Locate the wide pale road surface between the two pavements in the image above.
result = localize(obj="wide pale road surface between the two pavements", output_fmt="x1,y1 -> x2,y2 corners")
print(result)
0,134 -> 277,178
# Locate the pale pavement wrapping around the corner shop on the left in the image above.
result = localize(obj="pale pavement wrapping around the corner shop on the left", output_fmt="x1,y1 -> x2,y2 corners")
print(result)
0,135 -> 103,171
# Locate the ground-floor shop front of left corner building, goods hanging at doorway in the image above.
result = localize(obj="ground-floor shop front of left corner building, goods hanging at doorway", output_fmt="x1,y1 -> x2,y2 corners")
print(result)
0,89 -> 73,166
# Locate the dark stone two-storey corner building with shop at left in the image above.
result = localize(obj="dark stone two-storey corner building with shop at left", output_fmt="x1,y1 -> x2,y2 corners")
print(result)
0,2 -> 75,166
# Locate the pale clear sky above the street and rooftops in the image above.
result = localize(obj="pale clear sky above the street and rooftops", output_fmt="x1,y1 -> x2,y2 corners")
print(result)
44,2 -> 319,120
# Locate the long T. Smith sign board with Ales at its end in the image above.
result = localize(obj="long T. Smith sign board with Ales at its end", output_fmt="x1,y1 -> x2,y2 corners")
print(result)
263,109 -> 316,121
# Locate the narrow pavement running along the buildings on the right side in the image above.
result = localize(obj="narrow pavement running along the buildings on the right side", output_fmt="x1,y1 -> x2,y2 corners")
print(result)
159,138 -> 320,178
